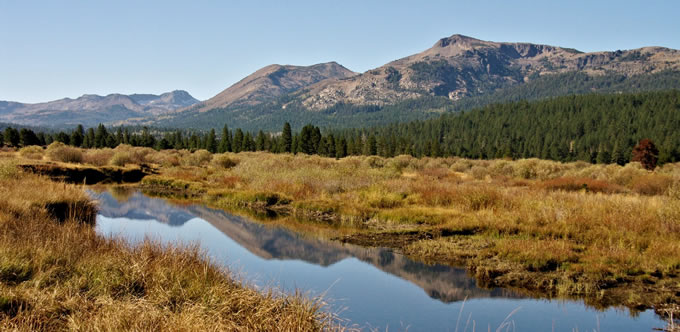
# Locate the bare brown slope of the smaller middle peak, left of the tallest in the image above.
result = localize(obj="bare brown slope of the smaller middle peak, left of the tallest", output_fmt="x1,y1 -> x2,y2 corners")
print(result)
187,62 -> 356,111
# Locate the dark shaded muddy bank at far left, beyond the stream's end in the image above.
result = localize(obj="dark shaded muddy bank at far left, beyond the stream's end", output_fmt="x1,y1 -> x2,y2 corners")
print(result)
19,163 -> 154,184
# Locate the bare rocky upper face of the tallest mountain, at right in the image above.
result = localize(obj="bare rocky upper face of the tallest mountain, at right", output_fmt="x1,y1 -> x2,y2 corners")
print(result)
299,35 -> 680,110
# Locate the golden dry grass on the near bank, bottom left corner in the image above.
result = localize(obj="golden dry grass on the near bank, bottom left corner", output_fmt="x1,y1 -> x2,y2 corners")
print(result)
0,154 -> 335,331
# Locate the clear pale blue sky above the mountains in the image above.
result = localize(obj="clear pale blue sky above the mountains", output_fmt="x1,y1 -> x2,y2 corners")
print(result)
0,0 -> 680,102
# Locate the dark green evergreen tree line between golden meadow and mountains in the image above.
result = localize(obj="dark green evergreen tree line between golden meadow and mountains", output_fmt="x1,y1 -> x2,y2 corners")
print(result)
3,90 -> 680,164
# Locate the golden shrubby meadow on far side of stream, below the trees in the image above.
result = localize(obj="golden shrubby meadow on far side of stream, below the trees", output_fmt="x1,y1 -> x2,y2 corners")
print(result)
5,146 -> 680,318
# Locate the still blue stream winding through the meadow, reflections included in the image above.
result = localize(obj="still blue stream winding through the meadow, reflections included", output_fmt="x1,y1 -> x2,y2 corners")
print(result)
93,188 -> 665,331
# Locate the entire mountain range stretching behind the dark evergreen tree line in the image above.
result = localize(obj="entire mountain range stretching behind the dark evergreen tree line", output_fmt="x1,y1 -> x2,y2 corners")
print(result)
5,35 -> 680,130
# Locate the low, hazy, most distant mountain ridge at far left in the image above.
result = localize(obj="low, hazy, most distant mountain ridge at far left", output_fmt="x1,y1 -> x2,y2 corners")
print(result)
0,90 -> 198,127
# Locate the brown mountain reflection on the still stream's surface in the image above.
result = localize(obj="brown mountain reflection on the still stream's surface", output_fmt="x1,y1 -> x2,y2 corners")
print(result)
97,188 -> 519,303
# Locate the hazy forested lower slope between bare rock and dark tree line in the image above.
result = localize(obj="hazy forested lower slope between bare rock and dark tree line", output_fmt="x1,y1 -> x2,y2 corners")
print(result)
154,71 -> 680,131
